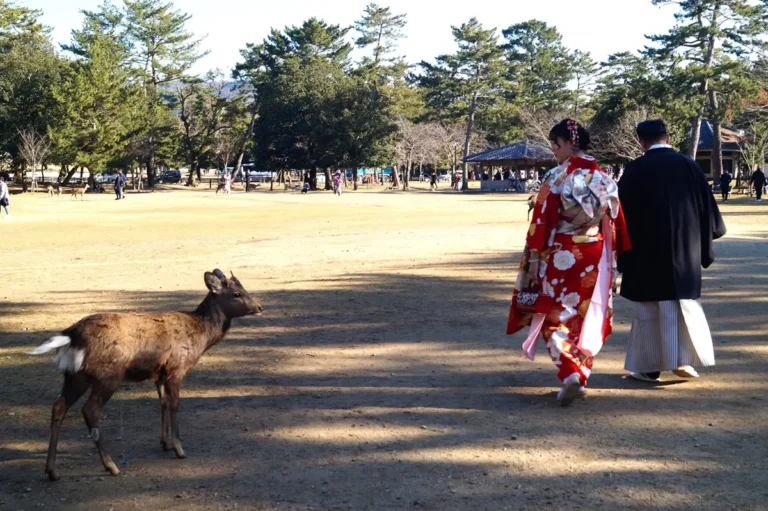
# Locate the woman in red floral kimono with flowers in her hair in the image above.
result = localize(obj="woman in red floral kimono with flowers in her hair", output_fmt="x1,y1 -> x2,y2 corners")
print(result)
507,119 -> 629,406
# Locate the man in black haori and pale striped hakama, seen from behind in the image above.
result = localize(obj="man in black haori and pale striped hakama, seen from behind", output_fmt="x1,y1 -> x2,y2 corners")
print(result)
618,120 -> 725,381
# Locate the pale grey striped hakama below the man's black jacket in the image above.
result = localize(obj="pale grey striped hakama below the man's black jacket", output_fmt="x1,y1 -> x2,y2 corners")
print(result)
624,300 -> 715,373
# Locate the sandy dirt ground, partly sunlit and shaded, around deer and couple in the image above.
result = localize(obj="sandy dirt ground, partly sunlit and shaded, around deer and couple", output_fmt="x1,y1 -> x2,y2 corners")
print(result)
0,185 -> 768,511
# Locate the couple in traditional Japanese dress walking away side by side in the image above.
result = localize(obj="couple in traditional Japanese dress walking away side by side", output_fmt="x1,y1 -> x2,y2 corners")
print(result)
507,119 -> 725,406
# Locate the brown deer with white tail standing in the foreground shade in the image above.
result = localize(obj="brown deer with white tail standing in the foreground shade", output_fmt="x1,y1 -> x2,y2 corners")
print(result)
29,269 -> 263,481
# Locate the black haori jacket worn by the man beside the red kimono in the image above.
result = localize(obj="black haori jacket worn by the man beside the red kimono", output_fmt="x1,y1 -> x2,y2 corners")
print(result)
619,148 -> 725,302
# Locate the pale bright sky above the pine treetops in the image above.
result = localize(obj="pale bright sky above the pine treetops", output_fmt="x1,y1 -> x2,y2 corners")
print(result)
28,0 -> 675,74
